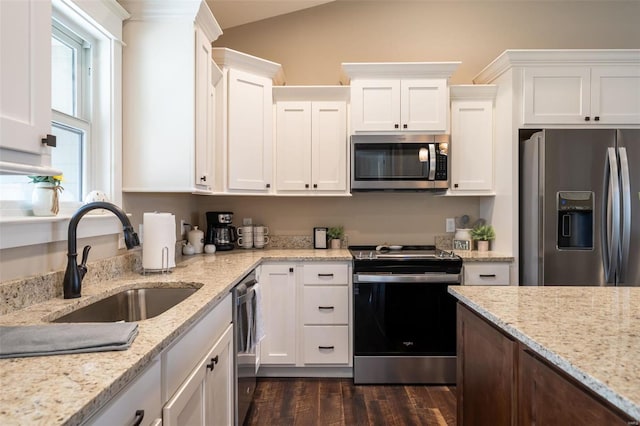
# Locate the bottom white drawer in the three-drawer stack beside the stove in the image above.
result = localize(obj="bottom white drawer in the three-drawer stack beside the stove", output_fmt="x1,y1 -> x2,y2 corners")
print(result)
303,325 -> 349,364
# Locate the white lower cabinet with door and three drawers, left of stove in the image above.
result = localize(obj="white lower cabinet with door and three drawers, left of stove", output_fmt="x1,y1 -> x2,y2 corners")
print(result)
259,262 -> 351,367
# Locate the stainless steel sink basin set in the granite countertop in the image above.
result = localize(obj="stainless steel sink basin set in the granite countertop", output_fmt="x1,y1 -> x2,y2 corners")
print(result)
52,288 -> 198,322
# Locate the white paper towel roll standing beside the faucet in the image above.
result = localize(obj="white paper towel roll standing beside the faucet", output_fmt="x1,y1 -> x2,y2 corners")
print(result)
142,212 -> 176,271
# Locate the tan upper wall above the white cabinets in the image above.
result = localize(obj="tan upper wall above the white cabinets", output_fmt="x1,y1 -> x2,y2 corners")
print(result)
214,0 -> 640,85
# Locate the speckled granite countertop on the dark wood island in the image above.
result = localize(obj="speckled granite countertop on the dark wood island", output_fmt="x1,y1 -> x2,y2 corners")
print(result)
449,286 -> 640,420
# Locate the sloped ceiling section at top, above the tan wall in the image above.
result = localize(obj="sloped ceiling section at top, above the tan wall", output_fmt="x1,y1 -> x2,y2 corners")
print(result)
206,0 -> 334,30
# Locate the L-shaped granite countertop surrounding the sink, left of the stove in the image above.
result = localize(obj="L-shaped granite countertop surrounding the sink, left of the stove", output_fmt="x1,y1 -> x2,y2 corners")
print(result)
0,249 -> 351,425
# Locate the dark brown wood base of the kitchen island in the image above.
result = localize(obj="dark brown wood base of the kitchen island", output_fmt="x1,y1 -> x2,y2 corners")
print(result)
456,303 -> 637,426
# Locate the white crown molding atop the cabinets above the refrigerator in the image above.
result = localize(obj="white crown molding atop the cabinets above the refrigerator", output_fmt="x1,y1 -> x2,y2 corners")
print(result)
473,49 -> 640,84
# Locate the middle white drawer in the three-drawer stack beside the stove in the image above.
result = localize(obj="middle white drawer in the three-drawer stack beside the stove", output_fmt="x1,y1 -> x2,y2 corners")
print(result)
302,285 -> 349,325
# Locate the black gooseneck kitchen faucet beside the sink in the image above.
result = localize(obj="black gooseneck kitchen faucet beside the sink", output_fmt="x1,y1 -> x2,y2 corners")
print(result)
62,201 -> 140,299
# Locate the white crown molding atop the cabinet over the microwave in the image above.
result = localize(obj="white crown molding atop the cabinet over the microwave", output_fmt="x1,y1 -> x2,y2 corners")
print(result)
341,62 -> 461,84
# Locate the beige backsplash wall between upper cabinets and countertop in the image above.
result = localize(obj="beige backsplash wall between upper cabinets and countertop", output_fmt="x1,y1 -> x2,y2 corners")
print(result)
125,192 -> 479,244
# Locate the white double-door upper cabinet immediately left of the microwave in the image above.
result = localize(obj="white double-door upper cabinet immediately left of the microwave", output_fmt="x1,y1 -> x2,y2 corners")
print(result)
274,86 -> 349,195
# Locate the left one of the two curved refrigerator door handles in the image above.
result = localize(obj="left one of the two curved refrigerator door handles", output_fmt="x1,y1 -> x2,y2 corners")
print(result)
600,147 -> 620,283
